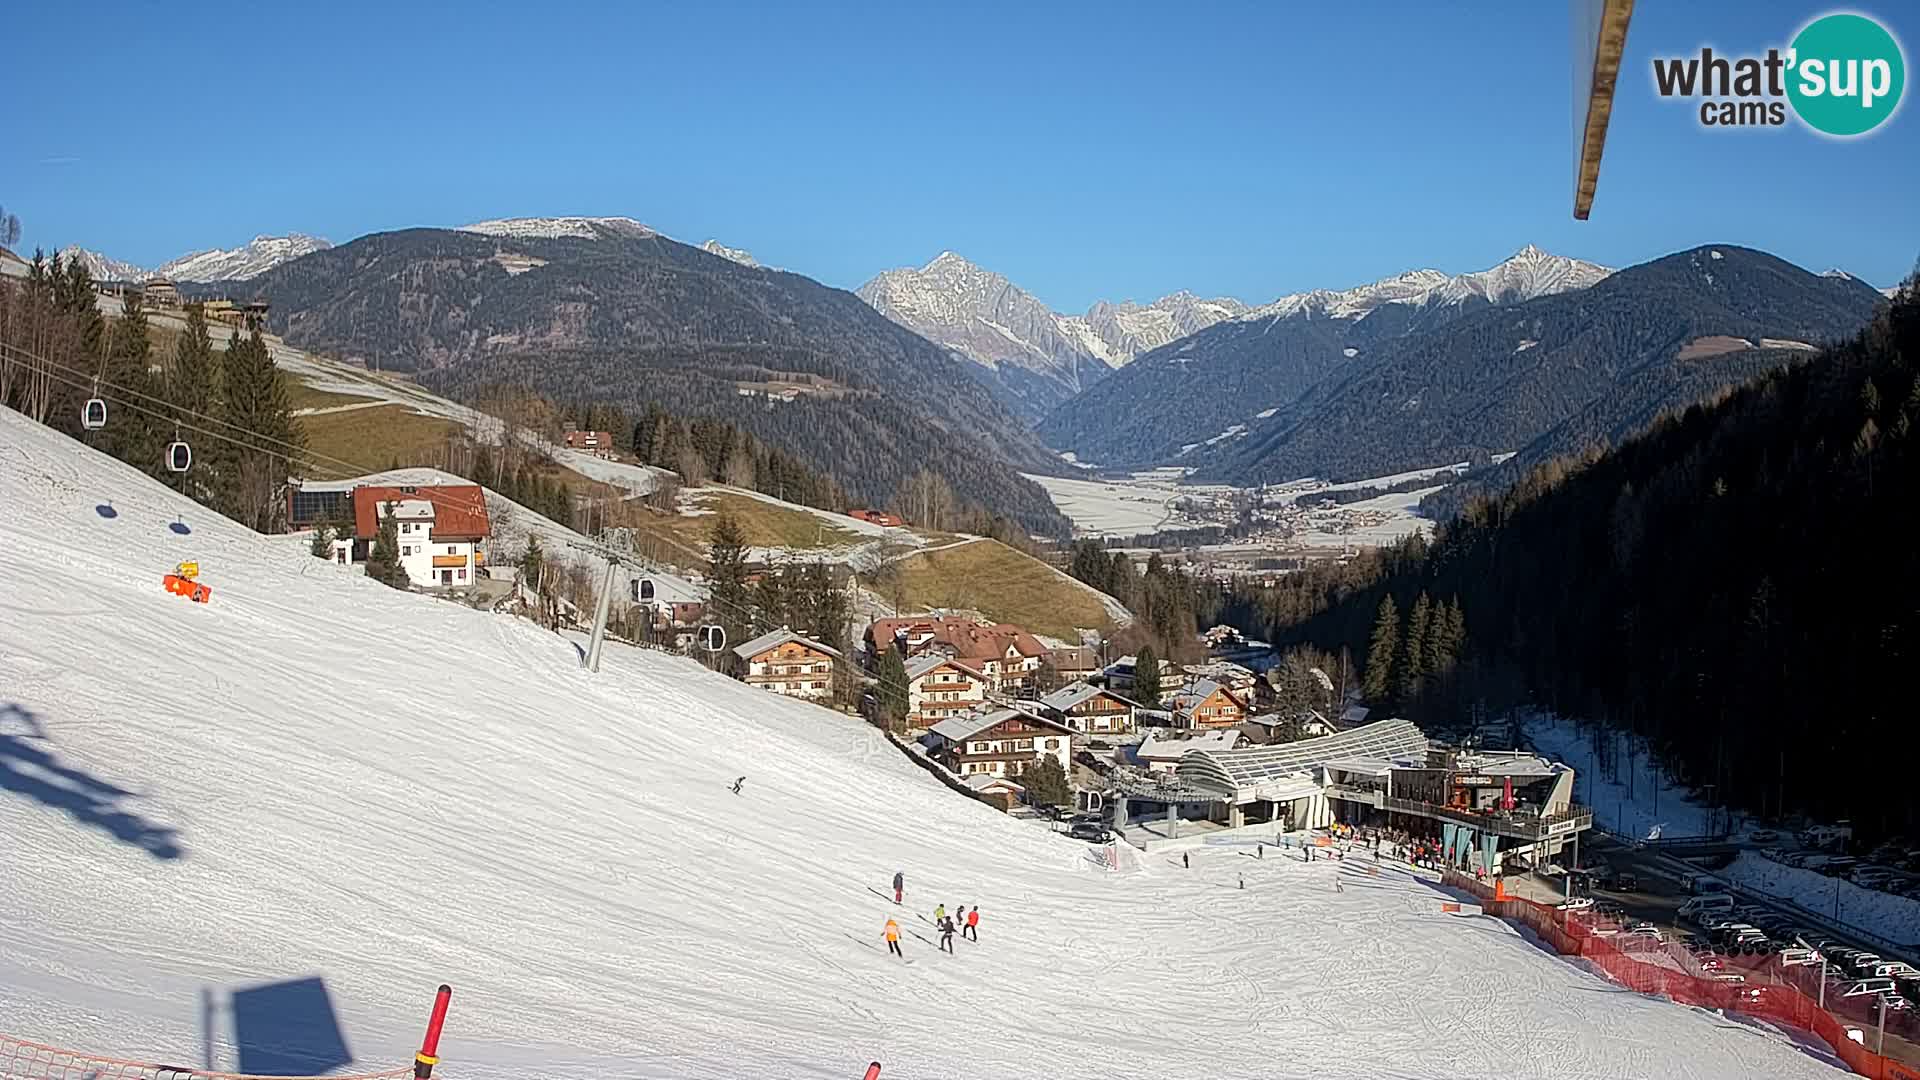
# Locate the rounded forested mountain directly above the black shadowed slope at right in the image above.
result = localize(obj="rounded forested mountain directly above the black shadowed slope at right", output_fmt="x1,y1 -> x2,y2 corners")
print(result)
1200,244 -> 1884,482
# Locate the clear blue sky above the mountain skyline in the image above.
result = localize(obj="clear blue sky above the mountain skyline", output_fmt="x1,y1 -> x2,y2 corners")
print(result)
0,0 -> 1920,309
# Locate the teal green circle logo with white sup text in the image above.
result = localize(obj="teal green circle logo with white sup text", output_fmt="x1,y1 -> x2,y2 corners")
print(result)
1788,13 -> 1907,136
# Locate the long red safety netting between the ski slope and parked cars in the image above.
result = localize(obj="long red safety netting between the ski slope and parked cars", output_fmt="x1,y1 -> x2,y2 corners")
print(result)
1442,871 -> 1920,1080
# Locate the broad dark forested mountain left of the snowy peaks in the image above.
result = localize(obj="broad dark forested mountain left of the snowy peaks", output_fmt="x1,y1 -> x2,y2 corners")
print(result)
232,219 -> 1068,534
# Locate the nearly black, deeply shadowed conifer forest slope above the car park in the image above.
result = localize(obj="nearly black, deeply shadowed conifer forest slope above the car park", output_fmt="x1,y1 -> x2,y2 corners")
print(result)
1265,276 -> 1920,834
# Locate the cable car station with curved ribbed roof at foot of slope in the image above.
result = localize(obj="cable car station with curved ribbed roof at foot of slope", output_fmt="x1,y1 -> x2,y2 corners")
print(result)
1106,721 -> 1594,872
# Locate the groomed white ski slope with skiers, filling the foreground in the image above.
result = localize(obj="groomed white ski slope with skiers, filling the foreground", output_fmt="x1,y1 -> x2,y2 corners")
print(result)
0,411 -> 1836,1080
